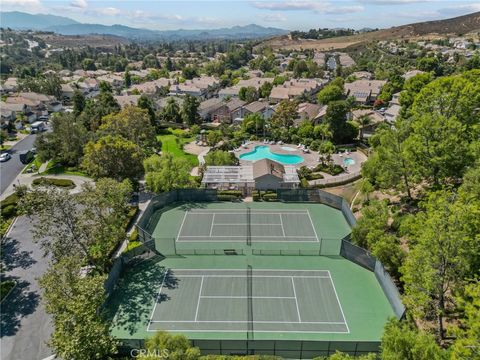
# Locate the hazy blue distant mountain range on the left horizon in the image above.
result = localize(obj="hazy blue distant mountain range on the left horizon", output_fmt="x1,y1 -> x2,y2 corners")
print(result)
0,11 -> 289,41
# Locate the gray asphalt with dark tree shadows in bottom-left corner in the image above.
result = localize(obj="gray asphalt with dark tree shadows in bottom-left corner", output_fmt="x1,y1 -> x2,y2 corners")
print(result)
0,216 -> 53,360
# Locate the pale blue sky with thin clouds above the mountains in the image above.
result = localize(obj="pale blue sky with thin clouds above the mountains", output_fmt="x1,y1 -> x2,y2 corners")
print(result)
0,0 -> 480,30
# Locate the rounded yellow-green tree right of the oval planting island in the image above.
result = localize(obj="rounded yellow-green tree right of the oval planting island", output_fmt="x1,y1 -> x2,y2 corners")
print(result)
82,135 -> 144,181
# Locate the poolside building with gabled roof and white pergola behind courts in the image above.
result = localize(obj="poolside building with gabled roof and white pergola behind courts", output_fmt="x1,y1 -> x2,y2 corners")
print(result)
202,159 -> 300,195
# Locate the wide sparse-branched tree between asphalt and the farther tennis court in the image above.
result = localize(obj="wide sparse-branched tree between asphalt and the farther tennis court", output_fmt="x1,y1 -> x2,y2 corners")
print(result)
19,179 -> 132,273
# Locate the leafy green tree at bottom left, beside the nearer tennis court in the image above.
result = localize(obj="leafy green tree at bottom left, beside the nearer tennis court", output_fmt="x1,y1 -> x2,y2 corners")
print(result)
39,254 -> 117,360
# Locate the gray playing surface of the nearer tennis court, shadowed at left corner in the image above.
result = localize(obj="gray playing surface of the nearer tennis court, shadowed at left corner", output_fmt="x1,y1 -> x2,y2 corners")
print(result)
147,269 -> 349,333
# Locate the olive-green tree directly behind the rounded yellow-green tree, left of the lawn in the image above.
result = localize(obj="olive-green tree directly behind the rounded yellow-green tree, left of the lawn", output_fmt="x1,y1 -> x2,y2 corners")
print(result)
97,106 -> 158,153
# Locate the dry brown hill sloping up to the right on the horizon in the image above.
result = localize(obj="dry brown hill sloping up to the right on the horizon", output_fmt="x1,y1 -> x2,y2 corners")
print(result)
256,12 -> 480,51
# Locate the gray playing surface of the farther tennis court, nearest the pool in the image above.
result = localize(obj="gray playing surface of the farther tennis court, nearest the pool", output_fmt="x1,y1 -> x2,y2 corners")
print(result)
176,209 -> 319,242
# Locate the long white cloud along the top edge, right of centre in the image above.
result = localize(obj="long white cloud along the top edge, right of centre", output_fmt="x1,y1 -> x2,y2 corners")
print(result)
251,0 -> 364,14
